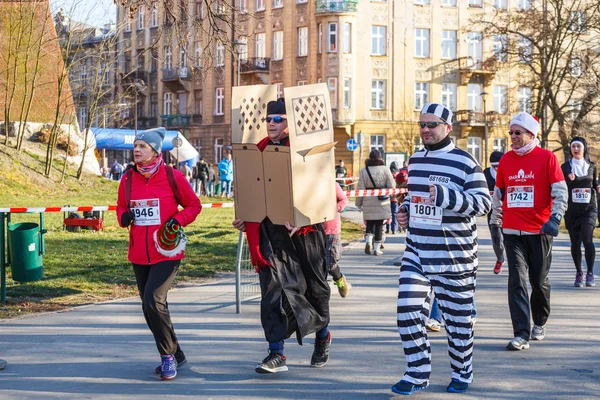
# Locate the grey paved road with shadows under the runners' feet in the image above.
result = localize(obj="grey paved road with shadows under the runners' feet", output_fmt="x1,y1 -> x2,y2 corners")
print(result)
0,207 -> 600,400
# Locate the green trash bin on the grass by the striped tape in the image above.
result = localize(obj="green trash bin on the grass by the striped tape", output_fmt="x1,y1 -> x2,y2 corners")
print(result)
8,222 -> 44,282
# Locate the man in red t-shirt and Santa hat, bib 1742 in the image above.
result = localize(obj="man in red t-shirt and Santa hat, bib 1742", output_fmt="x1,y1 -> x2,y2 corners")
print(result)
490,112 -> 568,350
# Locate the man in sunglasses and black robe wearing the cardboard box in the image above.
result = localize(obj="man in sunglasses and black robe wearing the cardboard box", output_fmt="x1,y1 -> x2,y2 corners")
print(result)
233,99 -> 331,374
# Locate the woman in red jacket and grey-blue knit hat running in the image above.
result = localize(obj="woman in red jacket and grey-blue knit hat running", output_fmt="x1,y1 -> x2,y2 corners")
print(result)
117,128 -> 202,379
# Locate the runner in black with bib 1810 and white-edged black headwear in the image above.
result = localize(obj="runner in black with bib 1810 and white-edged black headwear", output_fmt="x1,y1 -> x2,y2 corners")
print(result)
560,136 -> 600,287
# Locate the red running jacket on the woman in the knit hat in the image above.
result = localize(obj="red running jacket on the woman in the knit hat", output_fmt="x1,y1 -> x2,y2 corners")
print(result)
117,164 -> 202,265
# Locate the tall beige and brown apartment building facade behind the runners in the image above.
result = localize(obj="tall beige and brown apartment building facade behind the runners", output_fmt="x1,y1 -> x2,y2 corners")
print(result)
117,0 -> 572,174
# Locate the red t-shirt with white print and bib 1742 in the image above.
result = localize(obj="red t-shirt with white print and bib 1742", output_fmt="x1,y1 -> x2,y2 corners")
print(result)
496,147 -> 565,233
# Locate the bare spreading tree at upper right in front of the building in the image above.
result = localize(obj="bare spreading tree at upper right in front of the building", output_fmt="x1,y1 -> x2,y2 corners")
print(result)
473,0 -> 600,158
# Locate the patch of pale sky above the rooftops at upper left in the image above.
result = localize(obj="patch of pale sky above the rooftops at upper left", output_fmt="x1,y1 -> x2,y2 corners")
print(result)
50,0 -> 117,27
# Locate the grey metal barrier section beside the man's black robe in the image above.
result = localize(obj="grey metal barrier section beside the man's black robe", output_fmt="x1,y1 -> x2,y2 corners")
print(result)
235,232 -> 260,314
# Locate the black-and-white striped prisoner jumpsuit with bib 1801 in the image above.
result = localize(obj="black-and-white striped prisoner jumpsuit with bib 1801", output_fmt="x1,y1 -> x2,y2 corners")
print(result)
397,142 -> 491,385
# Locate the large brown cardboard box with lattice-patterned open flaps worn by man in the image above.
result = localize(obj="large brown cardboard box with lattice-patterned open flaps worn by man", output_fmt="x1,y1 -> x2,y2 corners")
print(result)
231,83 -> 337,227
